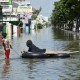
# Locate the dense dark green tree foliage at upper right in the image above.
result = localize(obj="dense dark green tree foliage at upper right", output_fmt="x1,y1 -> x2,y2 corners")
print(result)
51,0 -> 80,31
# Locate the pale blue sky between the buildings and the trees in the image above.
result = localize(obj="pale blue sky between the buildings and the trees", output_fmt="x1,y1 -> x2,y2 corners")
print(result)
30,0 -> 59,17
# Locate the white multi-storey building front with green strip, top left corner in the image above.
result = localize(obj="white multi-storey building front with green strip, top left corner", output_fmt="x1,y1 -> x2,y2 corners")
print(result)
0,0 -> 18,22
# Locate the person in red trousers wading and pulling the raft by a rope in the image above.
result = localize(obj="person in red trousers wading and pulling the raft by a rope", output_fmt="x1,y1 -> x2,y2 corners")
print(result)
1,34 -> 12,59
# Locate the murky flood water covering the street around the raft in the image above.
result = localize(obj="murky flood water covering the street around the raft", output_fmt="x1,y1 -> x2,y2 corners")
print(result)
0,27 -> 80,80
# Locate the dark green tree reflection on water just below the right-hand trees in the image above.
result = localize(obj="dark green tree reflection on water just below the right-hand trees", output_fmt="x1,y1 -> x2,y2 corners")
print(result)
52,28 -> 80,41
